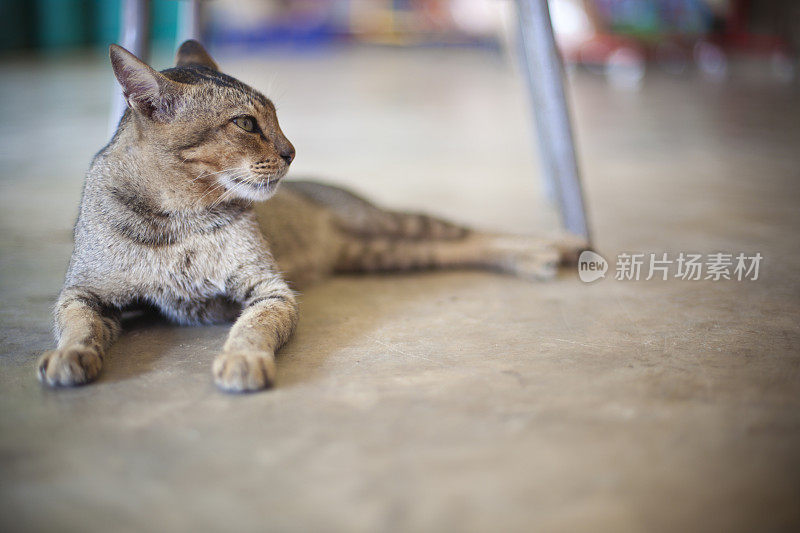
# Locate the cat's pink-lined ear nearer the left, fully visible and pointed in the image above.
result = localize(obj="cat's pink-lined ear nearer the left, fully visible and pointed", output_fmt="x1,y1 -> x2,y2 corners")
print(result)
108,44 -> 180,120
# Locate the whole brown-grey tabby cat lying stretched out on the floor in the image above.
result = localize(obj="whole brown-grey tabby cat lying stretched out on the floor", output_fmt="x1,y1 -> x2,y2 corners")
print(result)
37,41 -> 578,392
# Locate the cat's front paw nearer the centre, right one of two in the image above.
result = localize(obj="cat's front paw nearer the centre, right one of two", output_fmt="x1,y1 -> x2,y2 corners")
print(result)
212,351 -> 275,392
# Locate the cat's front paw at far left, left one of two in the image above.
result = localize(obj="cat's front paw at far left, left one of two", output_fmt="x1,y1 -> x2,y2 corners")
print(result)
36,346 -> 103,387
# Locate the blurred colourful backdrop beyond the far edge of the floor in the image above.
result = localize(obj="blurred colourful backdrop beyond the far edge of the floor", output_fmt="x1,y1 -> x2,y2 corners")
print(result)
0,0 -> 800,86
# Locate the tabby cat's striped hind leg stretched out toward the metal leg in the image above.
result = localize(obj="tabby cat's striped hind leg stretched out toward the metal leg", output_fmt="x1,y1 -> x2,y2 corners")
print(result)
287,181 -> 587,280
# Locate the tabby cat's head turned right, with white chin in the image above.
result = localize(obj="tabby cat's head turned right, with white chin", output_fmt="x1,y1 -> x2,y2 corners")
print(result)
110,41 -> 295,205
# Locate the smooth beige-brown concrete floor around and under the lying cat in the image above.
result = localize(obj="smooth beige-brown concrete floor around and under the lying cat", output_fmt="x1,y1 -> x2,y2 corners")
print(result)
0,50 -> 800,532
